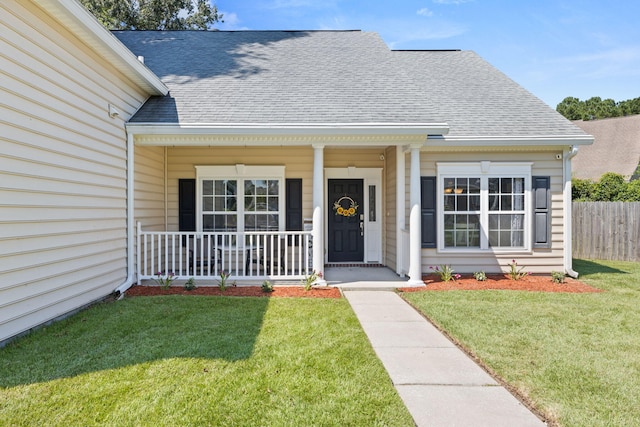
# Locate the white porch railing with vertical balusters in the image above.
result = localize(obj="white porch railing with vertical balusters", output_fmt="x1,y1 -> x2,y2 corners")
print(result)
137,223 -> 312,281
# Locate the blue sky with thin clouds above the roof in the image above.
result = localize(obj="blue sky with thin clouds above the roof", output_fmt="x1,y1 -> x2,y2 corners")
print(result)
214,0 -> 640,108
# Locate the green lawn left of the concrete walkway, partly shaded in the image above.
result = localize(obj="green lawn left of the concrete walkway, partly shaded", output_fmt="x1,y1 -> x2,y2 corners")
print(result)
0,296 -> 413,426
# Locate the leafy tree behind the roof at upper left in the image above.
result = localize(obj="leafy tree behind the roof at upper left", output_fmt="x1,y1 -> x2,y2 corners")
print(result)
81,0 -> 222,30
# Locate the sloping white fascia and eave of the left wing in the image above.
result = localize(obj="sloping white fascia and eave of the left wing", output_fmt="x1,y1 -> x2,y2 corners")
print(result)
37,0 -> 169,95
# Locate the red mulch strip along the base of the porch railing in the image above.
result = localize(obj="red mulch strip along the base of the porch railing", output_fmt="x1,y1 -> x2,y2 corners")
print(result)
125,286 -> 341,298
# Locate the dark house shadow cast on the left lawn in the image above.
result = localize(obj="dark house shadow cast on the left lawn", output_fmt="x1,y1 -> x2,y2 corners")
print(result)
0,296 -> 269,387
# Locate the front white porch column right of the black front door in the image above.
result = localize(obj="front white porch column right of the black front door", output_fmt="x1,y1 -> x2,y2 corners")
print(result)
408,145 -> 424,286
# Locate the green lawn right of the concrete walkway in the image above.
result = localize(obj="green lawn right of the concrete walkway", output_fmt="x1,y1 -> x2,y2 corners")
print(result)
404,260 -> 640,426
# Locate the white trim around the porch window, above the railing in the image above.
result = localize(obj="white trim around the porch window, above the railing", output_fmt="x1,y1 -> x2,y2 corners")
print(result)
195,164 -> 285,232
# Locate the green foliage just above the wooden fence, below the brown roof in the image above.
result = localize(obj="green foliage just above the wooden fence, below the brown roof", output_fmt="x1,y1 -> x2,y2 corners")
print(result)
571,172 -> 640,202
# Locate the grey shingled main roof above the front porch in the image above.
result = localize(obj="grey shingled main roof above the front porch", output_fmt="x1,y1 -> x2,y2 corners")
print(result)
114,31 -> 590,143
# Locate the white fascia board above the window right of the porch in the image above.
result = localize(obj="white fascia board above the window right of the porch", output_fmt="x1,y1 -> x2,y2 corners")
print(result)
426,135 -> 594,147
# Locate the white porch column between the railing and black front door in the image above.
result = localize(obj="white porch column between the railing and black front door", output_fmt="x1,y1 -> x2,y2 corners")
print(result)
312,144 -> 326,284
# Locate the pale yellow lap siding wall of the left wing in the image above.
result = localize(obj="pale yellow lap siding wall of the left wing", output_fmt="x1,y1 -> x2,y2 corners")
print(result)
0,0 -> 146,342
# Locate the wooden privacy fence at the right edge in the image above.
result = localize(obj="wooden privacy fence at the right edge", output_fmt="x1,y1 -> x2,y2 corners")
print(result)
571,202 -> 640,262
